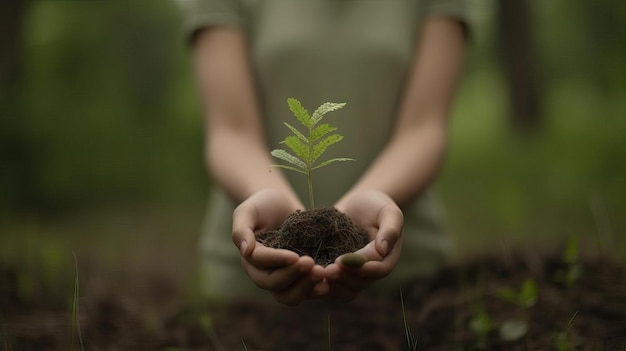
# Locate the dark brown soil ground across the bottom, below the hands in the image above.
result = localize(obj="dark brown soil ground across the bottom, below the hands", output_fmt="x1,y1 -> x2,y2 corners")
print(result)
0,246 -> 626,351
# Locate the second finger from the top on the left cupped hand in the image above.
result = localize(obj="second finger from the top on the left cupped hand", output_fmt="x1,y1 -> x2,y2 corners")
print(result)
242,257 -> 314,292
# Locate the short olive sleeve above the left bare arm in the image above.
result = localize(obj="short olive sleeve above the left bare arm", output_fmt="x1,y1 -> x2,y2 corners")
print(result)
182,0 -> 244,42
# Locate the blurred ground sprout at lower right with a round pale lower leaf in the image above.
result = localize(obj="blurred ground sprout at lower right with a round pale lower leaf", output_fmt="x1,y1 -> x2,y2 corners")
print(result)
497,278 -> 538,341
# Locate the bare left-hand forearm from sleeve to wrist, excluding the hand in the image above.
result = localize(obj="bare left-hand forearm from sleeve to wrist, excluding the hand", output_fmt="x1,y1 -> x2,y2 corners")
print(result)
194,28 -> 299,206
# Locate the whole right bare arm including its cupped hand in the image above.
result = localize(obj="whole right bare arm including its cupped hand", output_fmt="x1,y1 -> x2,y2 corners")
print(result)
324,19 -> 464,300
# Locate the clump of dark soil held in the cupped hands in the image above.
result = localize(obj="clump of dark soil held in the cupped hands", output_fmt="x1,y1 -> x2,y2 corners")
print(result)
257,207 -> 369,266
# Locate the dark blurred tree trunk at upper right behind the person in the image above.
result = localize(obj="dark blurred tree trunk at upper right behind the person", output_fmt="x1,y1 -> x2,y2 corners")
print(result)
496,0 -> 541,132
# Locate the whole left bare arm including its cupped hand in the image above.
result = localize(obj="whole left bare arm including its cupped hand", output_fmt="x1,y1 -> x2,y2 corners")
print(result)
194,27 -> 324,304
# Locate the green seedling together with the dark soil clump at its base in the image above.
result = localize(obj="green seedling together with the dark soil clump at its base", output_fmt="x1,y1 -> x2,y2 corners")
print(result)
257,98 -> 369,266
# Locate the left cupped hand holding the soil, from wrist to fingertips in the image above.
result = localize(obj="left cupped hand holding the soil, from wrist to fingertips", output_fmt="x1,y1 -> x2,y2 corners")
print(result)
233,189 -> 327,305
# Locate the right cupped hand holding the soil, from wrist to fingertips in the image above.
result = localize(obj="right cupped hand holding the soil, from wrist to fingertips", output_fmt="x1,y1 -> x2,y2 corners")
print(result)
318,191 -> 404,301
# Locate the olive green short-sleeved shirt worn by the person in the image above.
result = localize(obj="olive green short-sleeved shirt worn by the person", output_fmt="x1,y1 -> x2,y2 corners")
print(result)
187,0 -> 466,299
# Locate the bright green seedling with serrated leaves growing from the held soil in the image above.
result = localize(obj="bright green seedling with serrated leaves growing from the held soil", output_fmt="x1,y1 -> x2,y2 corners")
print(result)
271,98 -> 354,209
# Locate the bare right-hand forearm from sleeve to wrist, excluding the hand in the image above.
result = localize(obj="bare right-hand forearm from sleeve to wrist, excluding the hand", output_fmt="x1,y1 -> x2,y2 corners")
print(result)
338,19 -> 464,212
